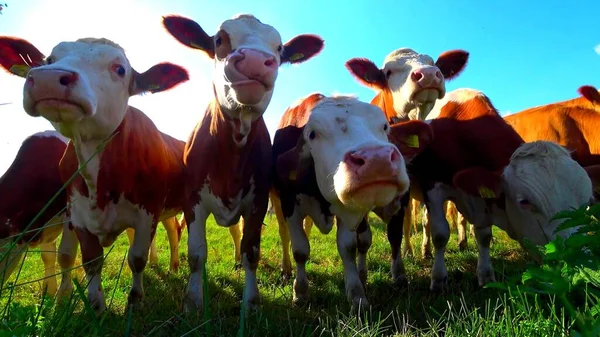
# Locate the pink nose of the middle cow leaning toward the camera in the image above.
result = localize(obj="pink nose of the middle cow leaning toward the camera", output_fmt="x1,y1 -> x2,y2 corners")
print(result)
344,146 -> 402,176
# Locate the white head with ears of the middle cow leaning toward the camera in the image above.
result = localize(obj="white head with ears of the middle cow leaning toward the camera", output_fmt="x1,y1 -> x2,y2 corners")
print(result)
276,94 -> 431,228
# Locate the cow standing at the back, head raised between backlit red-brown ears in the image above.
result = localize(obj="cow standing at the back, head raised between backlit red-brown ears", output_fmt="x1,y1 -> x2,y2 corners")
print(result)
345,48 -> 469,285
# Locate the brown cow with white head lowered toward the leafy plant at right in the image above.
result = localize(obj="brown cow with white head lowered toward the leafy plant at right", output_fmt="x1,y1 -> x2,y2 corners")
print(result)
409,88 -> 592,291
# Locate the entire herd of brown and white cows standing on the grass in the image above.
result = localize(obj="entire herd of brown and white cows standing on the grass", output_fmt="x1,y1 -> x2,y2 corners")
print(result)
0,14 -> 600,314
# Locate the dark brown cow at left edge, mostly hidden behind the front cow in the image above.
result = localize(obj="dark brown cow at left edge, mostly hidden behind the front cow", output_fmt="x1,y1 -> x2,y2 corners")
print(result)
0,130 -> 185,297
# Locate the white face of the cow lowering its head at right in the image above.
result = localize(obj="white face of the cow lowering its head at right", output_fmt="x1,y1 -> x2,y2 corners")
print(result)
503,141 -> 592,245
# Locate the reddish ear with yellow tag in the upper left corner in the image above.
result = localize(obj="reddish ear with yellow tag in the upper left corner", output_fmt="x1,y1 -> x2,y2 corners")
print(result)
0,36 -> 46,77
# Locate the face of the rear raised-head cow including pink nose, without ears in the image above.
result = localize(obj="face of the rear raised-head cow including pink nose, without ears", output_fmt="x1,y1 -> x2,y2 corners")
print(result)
383,48 -> 446,119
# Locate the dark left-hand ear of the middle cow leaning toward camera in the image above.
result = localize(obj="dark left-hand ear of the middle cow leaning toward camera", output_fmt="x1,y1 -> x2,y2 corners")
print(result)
275,133 -> 312,182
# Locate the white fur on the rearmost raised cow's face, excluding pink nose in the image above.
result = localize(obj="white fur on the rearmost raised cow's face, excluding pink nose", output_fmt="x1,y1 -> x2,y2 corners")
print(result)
382,48 -> 446,120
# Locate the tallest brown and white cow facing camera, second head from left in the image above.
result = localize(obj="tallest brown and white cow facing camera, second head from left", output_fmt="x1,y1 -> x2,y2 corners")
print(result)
163,14 -> 323,310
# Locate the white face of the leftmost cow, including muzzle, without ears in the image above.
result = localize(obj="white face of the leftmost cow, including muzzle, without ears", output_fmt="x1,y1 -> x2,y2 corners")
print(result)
23,39 -> 132,138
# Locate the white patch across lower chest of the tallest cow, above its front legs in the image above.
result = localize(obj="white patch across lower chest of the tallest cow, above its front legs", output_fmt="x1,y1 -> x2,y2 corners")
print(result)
198,176 -> 255,227
